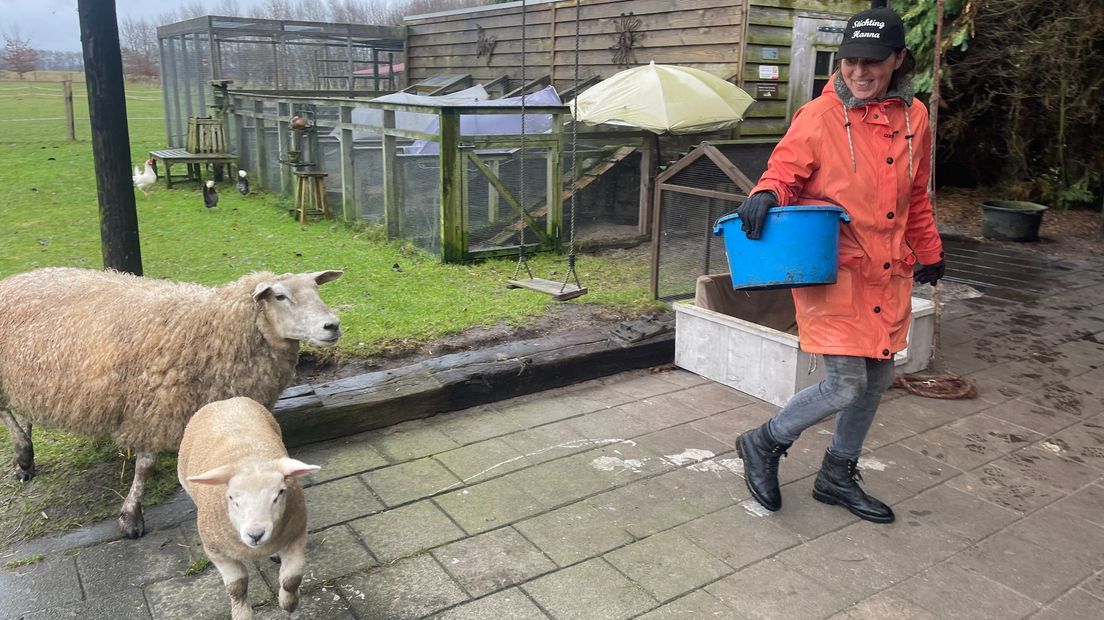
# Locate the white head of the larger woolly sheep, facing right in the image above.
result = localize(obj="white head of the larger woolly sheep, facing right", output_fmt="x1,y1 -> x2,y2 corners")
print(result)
253,271 -> 341,346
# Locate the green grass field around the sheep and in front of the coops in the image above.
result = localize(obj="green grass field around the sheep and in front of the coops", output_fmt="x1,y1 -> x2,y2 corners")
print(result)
0,81 -> 654,548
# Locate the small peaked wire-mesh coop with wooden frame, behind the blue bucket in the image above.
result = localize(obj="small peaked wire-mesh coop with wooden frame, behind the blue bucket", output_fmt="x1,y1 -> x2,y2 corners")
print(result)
651,140 -> 775,301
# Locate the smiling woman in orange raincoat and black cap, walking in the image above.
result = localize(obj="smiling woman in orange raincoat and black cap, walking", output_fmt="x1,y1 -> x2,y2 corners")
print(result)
736,8 -> 944,523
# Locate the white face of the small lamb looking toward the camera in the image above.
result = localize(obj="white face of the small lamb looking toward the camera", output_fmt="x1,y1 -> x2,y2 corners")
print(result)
226,469 -> 287,548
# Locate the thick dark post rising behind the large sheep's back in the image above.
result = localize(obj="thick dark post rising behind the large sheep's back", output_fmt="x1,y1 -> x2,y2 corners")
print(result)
77,0 -> 142,276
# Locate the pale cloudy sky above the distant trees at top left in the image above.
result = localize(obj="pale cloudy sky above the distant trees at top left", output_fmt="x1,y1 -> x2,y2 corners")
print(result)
0,0 -> 270,52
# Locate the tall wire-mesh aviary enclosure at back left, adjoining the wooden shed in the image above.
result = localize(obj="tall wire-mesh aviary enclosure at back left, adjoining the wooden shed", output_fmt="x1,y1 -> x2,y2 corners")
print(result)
157,15 -> 405,147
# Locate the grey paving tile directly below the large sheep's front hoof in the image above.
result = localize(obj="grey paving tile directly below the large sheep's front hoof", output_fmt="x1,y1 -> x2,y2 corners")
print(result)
76,527 -> 190,595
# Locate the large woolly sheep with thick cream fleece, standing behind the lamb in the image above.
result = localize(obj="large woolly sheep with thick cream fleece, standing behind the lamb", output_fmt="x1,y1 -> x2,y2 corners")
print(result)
0,268 -> 341,538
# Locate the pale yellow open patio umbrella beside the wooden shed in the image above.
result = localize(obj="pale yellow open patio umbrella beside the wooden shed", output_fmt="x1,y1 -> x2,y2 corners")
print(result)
569,62 -> 754,133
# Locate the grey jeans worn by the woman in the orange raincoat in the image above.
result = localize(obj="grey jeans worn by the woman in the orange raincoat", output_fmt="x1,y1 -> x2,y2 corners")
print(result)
767,355 -> 893,459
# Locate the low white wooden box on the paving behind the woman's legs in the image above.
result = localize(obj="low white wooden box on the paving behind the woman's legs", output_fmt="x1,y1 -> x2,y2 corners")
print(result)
675,276 -> 935,407
